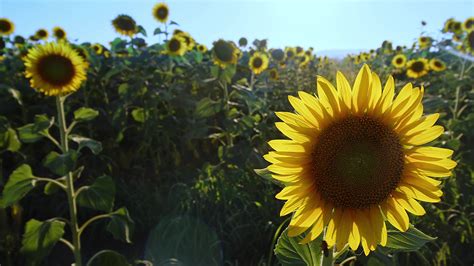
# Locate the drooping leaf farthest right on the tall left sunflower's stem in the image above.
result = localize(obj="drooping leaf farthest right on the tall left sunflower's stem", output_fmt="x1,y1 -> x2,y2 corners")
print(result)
107,207 -> 134,243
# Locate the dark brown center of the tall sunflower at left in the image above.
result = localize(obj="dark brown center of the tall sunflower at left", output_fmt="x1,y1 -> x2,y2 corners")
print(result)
38,55 -> 75,86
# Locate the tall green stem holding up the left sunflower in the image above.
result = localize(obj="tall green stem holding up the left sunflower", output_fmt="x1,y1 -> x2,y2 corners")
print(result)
56,96 -> 82,266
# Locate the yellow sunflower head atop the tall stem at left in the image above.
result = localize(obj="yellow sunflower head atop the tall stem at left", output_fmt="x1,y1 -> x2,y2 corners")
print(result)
25,43 -> 87,96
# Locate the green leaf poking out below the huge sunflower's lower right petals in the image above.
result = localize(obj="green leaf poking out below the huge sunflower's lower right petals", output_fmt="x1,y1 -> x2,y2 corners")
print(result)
380,225 -> 436,252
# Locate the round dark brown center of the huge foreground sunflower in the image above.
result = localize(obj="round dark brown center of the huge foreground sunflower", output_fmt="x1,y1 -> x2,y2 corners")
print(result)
313,116 -> 404,209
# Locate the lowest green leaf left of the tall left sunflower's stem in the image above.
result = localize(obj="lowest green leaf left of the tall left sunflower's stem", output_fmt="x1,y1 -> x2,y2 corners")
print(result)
20,219 -> 65,261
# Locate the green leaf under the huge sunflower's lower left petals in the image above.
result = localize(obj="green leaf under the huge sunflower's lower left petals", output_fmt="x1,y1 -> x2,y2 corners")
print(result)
275,228 -> 322,266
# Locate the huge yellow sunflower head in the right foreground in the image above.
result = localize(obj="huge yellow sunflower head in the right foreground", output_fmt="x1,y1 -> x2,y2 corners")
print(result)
264,65 -> 456,255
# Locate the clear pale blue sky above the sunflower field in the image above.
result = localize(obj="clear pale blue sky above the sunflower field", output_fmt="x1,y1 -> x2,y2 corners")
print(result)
0,0 -> 474,51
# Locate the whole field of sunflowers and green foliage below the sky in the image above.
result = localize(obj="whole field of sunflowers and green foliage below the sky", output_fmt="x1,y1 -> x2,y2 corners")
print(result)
0,3 -> 474,266
